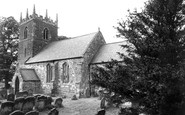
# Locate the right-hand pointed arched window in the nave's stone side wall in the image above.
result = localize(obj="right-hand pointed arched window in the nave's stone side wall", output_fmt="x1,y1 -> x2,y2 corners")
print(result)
63,62 -> 69,83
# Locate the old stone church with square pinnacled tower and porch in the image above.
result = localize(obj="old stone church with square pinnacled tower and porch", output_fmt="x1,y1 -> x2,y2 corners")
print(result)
12,6 -> 122,97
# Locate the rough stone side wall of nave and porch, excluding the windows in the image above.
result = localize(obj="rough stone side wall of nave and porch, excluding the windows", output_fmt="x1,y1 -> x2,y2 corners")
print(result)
13,58 -> 83,97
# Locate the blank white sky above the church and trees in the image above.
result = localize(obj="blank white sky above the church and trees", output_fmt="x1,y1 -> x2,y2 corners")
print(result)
0,0 -> 147,43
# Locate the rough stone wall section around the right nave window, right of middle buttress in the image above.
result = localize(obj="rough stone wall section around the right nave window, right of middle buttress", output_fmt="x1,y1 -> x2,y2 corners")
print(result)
57,58 -> 83,97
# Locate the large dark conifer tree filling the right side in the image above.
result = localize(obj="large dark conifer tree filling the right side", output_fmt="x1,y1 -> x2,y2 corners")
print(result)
92,0 -> 185,115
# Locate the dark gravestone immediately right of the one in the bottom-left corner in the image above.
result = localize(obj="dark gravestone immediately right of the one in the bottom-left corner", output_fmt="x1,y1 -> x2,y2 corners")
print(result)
13,97 -> 25,110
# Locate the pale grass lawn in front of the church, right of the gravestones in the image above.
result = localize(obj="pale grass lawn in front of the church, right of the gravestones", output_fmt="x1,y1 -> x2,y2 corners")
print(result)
40,98 -> 118,115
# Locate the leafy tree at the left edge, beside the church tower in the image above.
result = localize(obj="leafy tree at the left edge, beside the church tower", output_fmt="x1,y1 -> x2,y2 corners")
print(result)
0,17 -> 19,88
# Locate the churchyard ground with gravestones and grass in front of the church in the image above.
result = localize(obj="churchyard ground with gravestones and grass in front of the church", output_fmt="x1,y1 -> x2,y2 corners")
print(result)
0,92 -> 118,115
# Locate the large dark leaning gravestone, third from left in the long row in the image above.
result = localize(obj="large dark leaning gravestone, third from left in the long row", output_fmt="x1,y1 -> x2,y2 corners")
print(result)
22,96 -> 35,113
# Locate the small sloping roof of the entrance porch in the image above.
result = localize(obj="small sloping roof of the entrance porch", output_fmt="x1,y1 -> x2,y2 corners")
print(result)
20,69 -> 40,81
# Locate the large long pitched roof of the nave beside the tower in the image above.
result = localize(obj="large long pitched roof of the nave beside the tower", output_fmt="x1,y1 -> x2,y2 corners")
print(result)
26,32 -> 100,63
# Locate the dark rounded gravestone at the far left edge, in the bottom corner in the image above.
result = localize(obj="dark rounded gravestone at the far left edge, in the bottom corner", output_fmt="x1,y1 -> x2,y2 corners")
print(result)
0,101 -> 14,115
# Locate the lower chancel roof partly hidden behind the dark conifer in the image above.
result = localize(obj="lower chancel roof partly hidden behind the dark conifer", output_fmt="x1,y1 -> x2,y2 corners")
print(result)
91,42 -> 126,64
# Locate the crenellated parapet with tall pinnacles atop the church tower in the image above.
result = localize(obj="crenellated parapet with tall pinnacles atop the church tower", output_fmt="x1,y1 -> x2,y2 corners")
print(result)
20,5 -> 58,27
